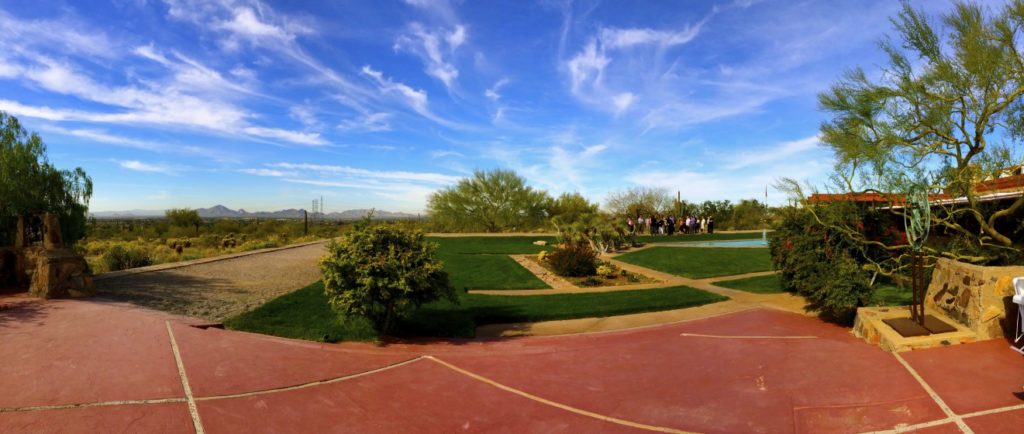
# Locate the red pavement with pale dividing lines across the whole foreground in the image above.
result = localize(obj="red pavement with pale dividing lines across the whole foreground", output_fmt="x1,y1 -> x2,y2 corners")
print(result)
0,297 -> 1024,433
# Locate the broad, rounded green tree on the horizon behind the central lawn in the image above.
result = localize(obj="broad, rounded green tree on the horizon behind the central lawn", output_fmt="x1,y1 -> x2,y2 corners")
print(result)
427,170 -> 550,232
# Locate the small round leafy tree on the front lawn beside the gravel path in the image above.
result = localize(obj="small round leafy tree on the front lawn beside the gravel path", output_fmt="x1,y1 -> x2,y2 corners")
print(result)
319,218 -> 458,334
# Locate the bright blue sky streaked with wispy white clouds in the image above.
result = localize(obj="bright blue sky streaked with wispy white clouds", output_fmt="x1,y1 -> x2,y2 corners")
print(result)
0,0 -> 995,212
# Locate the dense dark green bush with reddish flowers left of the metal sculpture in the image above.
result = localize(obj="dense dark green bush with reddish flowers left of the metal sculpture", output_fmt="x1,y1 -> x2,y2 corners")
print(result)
769,203 -> 871,320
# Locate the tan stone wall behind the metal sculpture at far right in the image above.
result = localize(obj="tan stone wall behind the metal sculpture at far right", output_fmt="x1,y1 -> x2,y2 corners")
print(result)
925,259 -> 1024,340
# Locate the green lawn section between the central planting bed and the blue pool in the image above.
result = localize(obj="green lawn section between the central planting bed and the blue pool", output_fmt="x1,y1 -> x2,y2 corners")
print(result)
615,247 -> 771,278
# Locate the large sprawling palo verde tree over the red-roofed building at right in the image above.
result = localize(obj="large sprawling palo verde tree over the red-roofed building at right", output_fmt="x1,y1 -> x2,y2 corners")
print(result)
783,0 -> 1024,274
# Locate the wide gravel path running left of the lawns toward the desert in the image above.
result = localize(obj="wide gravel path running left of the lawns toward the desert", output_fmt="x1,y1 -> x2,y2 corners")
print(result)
95,243 -> 326,321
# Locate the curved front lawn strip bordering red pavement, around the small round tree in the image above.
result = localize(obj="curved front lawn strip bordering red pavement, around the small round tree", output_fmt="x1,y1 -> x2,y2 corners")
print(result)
224,283 -> 725,342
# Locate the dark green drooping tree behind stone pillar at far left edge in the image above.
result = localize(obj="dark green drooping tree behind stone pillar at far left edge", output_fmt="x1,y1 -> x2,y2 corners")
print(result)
0,112 -> 92,245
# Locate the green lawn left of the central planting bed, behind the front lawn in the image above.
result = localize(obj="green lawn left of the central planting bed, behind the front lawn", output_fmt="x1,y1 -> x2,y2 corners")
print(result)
429,236 -> 555,291
